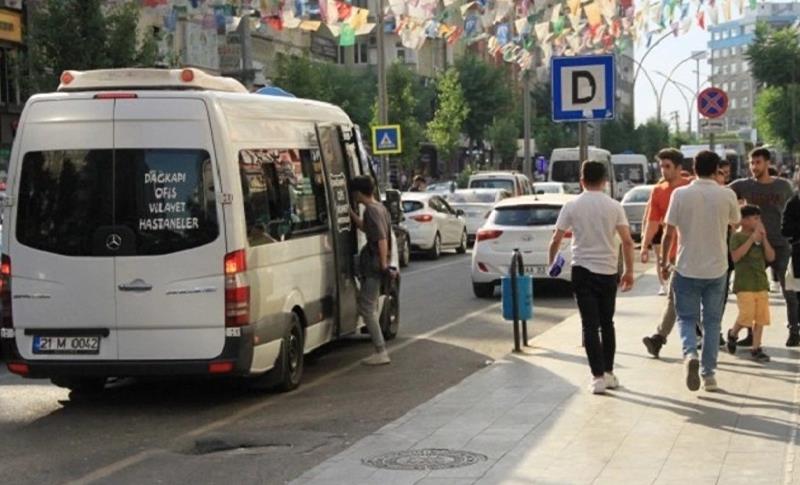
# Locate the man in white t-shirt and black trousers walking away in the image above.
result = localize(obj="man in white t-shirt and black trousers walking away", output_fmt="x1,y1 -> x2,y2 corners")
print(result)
549,161 -> 633,394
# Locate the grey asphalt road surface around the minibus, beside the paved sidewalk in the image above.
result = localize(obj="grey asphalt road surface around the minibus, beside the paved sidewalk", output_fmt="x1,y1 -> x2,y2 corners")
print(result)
0,250 -> 632,484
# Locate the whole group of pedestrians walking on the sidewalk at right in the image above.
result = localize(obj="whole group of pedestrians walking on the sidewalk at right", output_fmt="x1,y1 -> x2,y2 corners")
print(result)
550,148 -> 800,394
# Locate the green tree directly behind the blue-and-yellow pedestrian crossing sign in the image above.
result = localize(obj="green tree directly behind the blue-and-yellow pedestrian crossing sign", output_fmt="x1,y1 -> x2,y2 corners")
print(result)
372,63 -> 425,170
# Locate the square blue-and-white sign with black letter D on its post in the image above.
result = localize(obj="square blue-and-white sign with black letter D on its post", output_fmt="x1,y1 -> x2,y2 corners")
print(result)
550,55 -> 616,163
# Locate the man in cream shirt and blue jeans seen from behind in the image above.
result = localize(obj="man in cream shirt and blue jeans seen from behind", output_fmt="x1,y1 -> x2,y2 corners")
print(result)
661,150 -> 741,392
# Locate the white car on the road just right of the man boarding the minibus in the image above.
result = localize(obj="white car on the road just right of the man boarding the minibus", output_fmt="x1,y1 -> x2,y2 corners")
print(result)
402,192 -> 467,259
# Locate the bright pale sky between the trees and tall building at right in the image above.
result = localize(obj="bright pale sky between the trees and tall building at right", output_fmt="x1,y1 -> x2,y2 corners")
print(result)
634,5 -> 711,131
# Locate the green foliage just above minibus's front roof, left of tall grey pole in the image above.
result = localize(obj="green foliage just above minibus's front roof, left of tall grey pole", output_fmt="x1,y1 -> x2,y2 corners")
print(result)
272,54 -> 377,127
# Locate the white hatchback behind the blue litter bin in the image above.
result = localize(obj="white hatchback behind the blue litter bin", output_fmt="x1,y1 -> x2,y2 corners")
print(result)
472,194 -> 575,298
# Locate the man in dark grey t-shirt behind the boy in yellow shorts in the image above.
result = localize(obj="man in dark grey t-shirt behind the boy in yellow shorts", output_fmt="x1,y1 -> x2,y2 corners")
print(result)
730,148 -> 800,347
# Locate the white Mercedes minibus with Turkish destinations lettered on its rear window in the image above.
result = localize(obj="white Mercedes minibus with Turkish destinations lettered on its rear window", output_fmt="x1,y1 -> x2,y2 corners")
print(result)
0,69 -> 399,390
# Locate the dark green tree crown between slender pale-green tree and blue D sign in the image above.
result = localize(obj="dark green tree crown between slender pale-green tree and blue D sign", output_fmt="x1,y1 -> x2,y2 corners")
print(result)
455,55 -> 512,142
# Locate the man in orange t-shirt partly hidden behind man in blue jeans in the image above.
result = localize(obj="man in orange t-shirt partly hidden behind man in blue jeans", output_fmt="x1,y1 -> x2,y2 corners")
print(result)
641,148 -> 689,358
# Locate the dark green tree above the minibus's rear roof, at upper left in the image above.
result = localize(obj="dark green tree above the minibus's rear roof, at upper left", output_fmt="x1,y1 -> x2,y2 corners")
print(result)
27,0 -> 156,92
